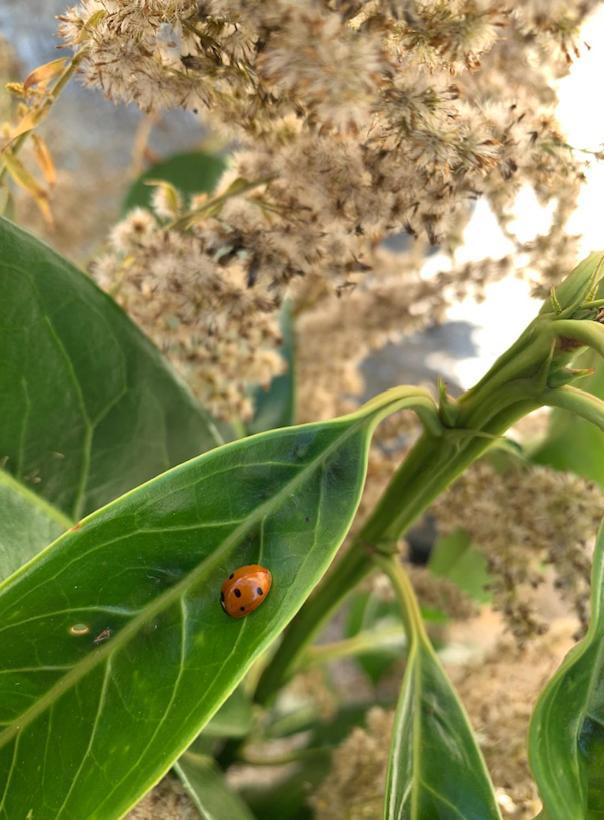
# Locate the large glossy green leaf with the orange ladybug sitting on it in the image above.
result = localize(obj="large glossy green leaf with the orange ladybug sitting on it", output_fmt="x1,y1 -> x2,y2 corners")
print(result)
0,390 -> 424,820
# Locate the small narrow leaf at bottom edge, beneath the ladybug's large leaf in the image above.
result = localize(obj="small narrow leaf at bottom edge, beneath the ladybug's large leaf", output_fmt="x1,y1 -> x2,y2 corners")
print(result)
174,752 -> 254,820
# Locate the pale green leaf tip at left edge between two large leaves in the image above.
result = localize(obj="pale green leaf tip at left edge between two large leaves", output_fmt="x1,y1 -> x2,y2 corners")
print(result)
0,470 -> 72,581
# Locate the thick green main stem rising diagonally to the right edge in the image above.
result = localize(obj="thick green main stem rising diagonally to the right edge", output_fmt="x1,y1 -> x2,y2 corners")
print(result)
255,264 -> 604,703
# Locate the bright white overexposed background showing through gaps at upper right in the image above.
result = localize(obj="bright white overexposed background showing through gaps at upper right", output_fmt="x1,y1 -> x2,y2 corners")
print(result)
426,9 -> 604,388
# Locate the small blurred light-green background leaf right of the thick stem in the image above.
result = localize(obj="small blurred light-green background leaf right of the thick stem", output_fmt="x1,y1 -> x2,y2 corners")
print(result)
428,530 -> 490,603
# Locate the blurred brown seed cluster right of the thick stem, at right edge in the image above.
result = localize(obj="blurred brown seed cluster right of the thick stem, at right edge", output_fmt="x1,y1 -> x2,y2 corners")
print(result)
433,463 -> 604,643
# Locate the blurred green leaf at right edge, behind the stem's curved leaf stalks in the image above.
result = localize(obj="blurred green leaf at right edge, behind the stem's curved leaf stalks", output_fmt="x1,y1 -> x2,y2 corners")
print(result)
531,351 -> 604,487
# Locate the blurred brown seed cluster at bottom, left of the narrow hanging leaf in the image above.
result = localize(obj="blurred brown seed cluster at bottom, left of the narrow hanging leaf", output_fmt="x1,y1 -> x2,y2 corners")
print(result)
310,707 -> 393,820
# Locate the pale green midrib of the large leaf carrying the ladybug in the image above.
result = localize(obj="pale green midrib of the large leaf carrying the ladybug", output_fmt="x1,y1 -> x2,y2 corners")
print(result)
0,414 -> 373,748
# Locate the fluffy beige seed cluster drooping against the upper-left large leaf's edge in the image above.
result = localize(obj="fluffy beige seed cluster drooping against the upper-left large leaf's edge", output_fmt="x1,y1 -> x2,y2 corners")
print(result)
94,206 -> 283,419
